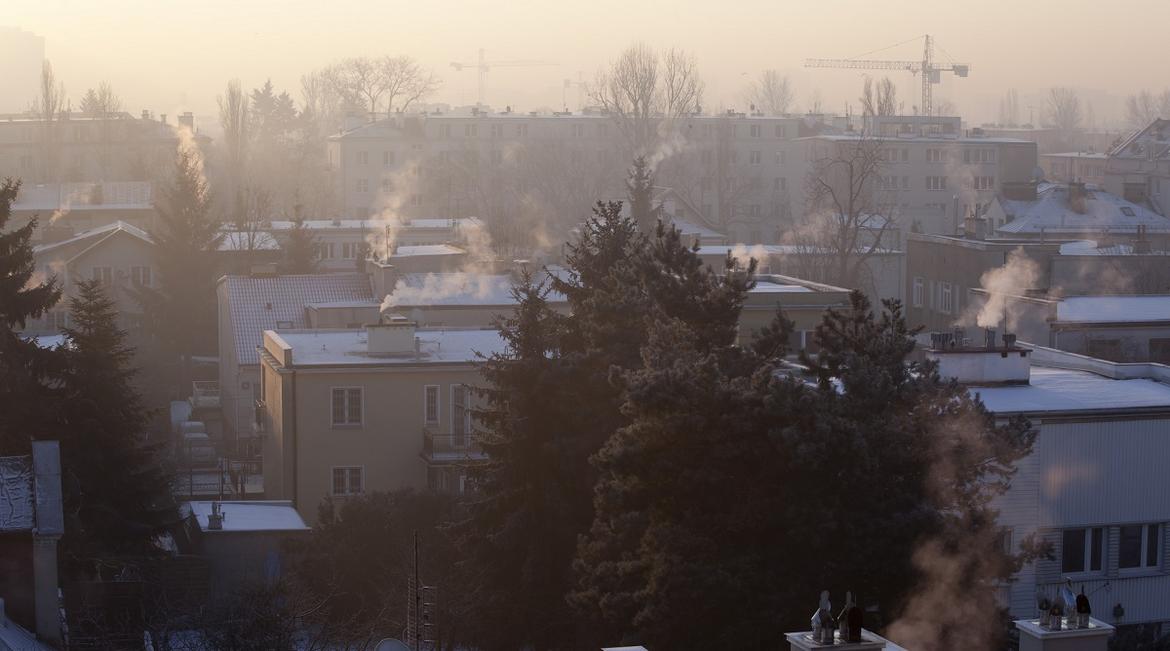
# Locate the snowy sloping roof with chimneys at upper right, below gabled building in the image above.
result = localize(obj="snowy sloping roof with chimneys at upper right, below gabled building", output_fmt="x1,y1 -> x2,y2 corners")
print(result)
996,184 -> 1170,234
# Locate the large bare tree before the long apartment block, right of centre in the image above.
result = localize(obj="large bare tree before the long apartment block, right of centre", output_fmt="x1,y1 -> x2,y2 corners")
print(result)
790,136 -> 896,288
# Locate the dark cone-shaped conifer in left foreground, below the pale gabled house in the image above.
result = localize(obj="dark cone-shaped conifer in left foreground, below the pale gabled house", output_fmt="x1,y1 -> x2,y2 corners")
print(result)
60,280 -> 178,562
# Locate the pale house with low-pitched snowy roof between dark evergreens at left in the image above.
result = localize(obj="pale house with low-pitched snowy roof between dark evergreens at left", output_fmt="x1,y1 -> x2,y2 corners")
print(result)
23,221 -> 158,336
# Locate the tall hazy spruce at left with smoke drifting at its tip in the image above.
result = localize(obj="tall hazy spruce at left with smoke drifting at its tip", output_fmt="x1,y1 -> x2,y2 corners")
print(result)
140,148 -> 223,391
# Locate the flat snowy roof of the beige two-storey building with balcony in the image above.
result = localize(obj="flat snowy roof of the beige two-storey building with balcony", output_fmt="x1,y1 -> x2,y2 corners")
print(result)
273,328 -> 505,366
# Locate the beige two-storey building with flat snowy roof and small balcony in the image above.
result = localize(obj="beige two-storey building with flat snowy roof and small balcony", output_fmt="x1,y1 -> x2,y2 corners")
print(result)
260,318 -> 504,525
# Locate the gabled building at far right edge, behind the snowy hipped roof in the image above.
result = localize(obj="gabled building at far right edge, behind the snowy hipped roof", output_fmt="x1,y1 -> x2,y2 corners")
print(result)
1104,119 -> 1170,215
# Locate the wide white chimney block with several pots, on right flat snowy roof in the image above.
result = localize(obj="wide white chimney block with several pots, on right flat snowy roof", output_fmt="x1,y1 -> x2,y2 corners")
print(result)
927,328 -> 1032,386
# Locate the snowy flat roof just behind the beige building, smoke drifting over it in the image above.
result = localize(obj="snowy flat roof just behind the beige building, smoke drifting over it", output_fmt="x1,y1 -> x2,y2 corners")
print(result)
386,272 -> 566,308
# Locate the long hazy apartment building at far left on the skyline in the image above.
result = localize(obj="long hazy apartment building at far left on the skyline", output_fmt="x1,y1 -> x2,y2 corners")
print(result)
0,111 -> 211,184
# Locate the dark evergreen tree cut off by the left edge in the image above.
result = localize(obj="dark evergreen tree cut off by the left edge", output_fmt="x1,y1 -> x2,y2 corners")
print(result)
0,179 -> 61,455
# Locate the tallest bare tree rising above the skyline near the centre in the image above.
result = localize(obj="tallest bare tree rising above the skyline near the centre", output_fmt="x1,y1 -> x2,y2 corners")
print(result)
589,43 -> 703,155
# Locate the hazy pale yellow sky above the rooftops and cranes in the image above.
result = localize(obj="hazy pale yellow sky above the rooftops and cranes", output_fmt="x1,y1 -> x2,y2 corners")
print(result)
9,0 -> 1170,125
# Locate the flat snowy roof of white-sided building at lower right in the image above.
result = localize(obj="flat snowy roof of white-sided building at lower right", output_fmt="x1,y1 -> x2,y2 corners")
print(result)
970,365 -> 1170,413
